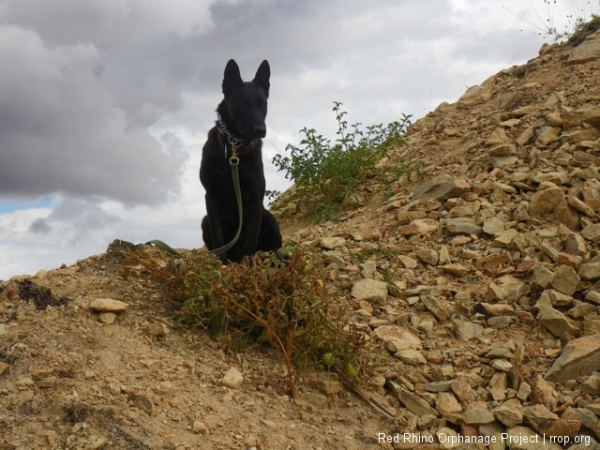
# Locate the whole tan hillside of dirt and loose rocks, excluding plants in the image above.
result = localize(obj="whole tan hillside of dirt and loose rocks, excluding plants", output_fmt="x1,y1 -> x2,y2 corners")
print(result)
0,32 -> 600,450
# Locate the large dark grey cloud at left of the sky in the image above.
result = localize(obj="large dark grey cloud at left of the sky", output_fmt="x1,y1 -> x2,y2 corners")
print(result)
0,25 -> 179,203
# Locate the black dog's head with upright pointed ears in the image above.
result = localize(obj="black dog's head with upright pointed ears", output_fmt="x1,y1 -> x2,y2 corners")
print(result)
223,59 -> 271,139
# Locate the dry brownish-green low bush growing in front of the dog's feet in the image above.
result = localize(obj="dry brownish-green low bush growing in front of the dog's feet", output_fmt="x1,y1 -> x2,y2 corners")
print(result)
123,249 -> 365,393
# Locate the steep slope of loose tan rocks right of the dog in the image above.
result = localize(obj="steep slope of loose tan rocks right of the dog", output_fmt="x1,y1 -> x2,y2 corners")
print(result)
282,32 -> 600,449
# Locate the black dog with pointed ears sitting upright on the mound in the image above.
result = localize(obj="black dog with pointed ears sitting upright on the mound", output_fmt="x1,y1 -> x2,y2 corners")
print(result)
200,59 -> 282,263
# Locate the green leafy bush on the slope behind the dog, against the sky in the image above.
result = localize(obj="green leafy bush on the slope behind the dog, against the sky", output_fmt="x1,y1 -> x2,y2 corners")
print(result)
273,102 -> 420,221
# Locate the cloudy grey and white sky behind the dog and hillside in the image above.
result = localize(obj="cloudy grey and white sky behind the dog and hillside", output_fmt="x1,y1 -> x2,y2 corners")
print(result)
0,0 -> 584,280
